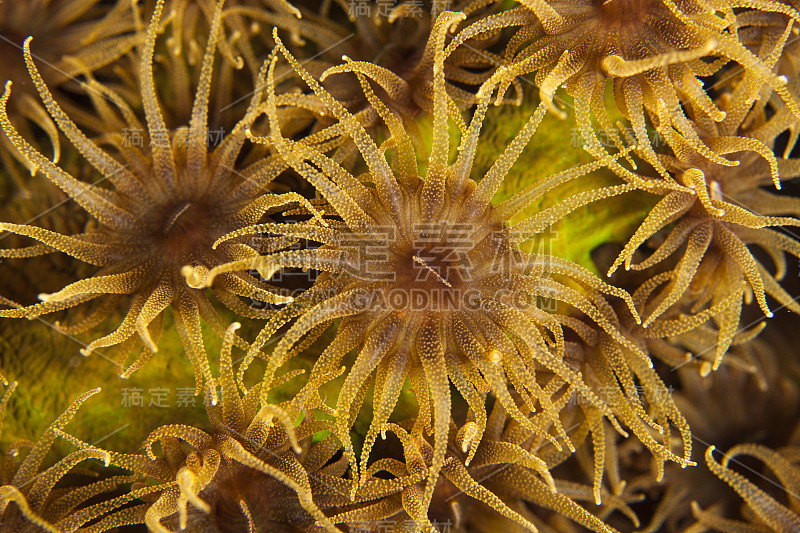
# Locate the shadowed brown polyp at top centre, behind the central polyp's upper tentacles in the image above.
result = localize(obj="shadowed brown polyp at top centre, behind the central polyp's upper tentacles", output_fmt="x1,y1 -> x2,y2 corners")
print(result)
229,0 -> 521,141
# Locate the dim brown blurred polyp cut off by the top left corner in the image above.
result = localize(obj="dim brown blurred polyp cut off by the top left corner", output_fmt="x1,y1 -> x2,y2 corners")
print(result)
0,0 -> 141,193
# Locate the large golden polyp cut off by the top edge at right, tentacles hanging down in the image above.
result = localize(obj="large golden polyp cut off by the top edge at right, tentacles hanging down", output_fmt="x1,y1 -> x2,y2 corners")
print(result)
452,0 -> 800,178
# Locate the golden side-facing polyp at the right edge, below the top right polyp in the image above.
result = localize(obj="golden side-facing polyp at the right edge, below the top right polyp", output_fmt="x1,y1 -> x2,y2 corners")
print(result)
608,76 -> 800,372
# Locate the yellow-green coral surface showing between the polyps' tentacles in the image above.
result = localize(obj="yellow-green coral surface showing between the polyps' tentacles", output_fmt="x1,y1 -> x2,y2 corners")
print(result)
0,86 -> 651,458
